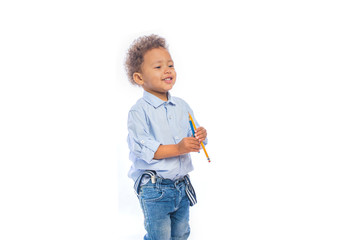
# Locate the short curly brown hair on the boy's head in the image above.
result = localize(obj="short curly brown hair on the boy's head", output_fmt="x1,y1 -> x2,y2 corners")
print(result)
125,34 -> 168,85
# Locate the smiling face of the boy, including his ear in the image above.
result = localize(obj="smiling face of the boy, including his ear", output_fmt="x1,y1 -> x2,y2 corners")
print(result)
134,48 -> 176,101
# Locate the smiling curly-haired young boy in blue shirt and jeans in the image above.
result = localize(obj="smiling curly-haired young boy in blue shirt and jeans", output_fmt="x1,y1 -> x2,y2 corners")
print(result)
125,35 -> 207,240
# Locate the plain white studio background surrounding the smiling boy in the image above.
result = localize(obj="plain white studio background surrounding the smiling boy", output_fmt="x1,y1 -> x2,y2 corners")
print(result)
0,0 -> 338,240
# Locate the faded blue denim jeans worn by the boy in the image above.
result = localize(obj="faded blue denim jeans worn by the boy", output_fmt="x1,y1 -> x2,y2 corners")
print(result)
139,178 -> 190,240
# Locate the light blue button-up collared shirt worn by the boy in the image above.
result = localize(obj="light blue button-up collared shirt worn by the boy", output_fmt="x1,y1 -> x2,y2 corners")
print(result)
128,91 -> 206,181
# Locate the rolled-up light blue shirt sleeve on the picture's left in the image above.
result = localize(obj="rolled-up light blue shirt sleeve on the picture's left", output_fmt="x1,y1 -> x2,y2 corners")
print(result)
128,110 -> 161,163
